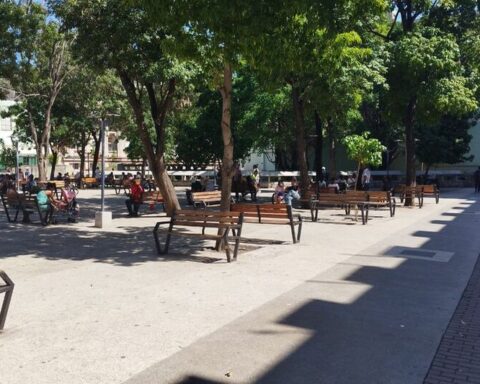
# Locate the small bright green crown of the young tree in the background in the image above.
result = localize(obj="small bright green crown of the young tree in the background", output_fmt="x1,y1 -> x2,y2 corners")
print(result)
342,131 -> 386,168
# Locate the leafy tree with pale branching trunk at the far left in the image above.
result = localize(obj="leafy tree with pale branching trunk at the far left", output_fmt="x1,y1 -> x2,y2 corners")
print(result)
1,2 -> 70,180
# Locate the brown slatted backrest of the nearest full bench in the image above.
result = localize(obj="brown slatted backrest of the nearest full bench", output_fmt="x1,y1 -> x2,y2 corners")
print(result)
171,209 -> 243,228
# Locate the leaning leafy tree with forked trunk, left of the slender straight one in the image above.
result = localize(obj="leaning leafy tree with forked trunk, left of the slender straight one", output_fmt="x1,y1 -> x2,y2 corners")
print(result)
52,0 -> 189,213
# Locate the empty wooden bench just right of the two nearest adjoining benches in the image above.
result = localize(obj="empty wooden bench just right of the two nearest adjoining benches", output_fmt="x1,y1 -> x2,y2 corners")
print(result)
310,191 -> 369,225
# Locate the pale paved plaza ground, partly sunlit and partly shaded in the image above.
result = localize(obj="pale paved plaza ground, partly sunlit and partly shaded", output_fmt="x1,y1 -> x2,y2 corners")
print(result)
0,189 -> 480,384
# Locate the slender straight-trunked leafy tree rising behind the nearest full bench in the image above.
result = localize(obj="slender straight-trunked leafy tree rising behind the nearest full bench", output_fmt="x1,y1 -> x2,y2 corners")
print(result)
140,0 -> 273,210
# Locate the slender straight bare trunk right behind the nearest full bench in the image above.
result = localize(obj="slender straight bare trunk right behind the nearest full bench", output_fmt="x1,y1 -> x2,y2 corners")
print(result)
219,63 -> 234,211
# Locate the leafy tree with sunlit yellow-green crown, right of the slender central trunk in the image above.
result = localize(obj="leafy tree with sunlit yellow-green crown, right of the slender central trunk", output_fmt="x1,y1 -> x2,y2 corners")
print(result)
251,0 -> 382,198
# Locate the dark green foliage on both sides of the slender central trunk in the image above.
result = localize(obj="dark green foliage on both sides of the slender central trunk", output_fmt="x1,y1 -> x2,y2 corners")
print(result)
172,68 -> 293,164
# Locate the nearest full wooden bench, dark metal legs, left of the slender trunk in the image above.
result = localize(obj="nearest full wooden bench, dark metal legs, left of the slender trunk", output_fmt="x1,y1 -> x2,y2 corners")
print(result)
153,210 -> 243,262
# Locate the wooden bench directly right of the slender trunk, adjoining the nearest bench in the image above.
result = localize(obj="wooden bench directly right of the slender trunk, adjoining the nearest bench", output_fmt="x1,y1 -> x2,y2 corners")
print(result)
230,203 -> 303,243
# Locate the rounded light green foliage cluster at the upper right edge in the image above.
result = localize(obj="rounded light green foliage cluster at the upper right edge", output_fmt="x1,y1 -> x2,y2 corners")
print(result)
387,28 -> 477,123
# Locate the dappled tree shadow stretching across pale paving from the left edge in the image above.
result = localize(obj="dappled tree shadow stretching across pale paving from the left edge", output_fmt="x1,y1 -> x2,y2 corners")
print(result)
0,222 -> 262,266
